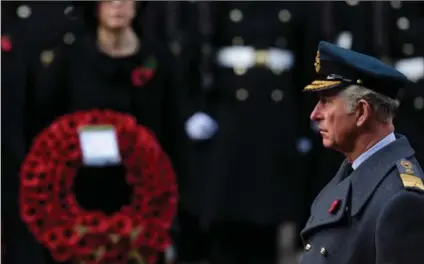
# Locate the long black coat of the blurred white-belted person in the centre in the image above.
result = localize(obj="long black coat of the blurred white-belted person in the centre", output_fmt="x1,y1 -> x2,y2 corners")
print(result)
181,2 -> 310,224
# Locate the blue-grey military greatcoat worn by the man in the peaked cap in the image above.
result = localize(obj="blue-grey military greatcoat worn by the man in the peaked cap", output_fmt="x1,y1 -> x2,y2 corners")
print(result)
301,135 -> 424,264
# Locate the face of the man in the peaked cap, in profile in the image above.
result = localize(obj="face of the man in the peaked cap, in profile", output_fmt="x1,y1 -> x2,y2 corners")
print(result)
310,92 -> 357,152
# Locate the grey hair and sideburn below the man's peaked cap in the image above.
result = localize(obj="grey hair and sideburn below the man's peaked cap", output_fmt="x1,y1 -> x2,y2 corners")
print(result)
340,85 -> 400,123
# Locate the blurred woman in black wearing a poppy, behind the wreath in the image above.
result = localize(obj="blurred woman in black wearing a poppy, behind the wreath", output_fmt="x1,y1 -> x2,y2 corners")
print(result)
29,0 -> 187,263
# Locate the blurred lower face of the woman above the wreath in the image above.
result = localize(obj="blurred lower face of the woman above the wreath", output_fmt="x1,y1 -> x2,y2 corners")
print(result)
98,0 -> 135,30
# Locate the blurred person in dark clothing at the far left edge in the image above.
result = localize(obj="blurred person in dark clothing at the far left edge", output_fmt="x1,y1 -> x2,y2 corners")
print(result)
1,1 -> 82,264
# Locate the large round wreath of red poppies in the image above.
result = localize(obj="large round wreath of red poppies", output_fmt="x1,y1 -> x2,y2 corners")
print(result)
20,110 -> 177,264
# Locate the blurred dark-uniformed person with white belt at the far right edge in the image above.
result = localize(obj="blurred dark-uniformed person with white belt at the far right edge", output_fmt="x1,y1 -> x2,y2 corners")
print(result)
386,1 -> 424,167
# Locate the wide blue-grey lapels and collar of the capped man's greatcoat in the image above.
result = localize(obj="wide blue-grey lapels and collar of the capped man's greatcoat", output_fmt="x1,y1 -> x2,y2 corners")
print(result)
300,135 -> 414,240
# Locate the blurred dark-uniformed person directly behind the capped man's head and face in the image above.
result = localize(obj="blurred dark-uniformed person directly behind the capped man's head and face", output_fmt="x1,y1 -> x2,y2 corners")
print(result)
301,0 -> 388,210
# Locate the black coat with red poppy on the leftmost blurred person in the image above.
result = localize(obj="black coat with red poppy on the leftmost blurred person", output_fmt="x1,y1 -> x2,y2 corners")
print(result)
1,13 -> 45,264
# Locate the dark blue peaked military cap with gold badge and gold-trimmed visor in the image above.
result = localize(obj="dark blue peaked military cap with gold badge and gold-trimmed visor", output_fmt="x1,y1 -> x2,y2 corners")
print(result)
303,41 -> 409,99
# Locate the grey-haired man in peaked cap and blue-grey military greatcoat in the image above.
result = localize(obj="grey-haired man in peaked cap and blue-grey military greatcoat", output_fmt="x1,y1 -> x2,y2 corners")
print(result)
301,41 -> 424,264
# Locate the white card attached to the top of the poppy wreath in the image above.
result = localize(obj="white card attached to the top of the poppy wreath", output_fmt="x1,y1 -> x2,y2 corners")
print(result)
79,125 -> 121,167
